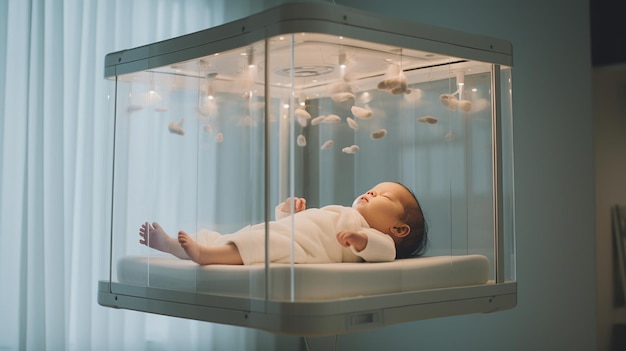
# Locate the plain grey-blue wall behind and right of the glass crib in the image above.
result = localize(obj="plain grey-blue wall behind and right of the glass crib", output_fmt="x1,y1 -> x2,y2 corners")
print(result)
226,0 -> 597,350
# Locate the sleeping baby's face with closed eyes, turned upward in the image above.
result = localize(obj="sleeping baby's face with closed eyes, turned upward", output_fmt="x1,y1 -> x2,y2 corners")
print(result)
353,182 -> 414,234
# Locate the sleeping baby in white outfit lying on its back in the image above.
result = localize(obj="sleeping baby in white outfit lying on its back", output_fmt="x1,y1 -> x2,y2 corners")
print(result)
139,182 -> 427,265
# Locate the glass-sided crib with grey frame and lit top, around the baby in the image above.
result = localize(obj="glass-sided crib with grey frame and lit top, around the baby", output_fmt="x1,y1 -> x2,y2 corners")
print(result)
98,3 -> 517,335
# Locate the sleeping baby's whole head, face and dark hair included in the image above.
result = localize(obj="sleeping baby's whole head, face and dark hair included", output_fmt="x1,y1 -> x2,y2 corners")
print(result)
353,182 -> 428,258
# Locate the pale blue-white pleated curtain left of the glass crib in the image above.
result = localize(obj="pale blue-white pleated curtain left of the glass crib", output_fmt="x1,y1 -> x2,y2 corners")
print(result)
0,0 -> 280,350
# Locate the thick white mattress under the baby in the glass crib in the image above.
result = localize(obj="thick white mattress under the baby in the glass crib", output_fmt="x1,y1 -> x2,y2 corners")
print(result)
117,255 -> 489,301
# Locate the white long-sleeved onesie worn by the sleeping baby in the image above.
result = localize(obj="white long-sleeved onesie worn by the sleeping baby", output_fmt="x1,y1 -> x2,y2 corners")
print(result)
197,205 -> 396,264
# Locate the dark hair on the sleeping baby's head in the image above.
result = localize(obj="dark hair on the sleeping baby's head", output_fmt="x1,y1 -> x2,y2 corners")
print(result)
396,183 -> 428,258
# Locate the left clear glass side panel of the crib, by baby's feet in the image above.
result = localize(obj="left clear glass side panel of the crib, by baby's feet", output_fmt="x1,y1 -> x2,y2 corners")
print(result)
112,42 -> 266,306
